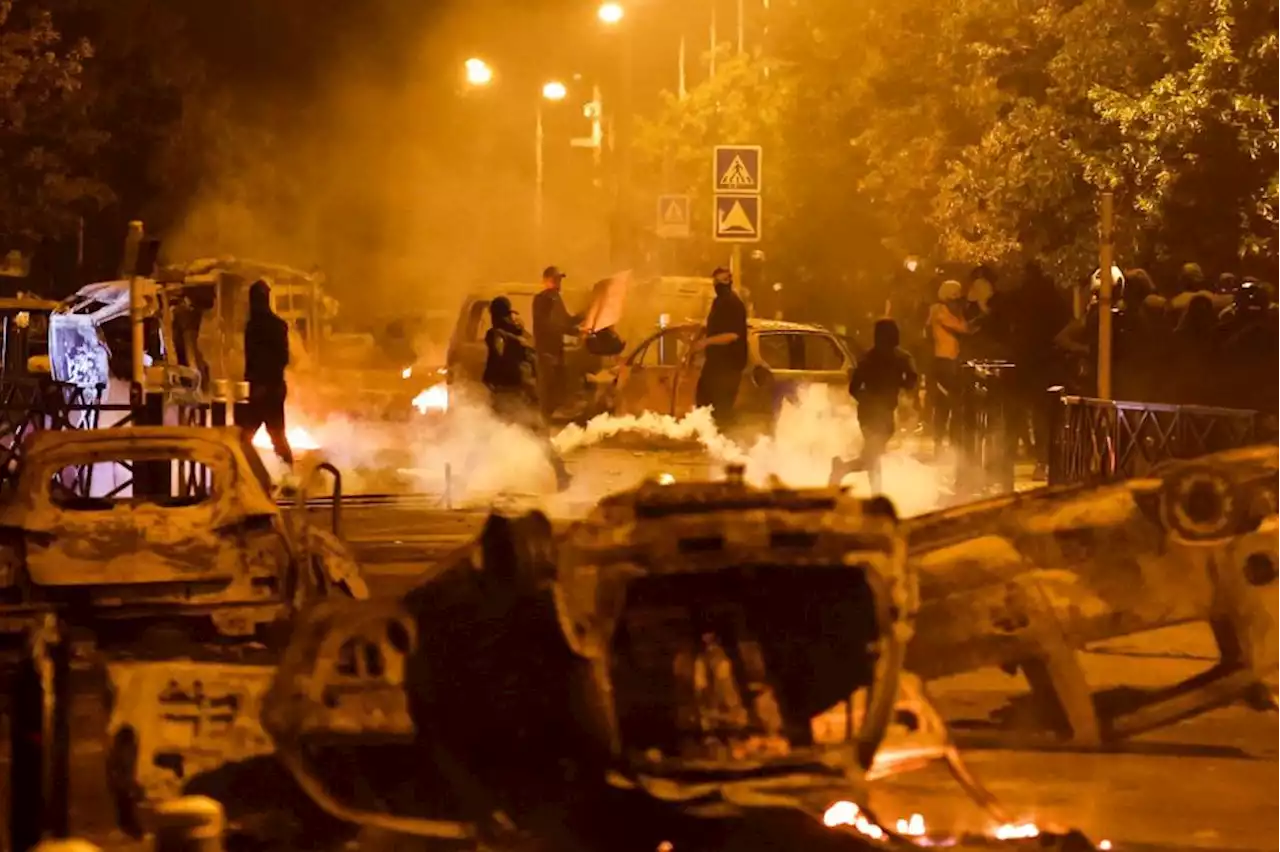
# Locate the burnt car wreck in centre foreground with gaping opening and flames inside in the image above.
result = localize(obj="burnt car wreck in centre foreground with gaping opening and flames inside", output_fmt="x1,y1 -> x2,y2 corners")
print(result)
264,476 -> 1092,852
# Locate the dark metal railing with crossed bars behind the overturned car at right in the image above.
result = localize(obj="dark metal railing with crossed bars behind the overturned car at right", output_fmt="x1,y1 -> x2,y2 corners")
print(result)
1047,388 -> 1275,485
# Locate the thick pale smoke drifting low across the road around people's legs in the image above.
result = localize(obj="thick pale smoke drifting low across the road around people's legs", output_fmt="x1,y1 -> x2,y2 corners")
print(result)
272,385 -> 948,516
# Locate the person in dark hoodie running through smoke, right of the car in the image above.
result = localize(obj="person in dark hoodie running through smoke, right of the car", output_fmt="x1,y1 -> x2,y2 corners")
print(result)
831,319 -> 920,491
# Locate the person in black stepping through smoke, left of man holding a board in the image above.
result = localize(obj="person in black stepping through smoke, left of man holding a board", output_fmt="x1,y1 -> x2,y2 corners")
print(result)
481,296 -> 571,491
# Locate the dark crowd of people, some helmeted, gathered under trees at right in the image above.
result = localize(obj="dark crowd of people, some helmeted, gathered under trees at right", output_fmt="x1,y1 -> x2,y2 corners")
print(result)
910,258 -> 1280,467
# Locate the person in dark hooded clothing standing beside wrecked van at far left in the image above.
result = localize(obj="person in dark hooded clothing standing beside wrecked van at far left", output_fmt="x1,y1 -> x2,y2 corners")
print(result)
237,281 -> 293,467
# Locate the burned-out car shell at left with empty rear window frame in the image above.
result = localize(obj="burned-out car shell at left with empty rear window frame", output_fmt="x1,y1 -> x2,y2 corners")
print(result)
0,427 -> 367,636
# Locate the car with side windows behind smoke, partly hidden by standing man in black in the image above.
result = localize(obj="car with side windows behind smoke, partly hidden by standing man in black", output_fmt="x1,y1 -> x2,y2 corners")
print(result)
600,320 -> 854,418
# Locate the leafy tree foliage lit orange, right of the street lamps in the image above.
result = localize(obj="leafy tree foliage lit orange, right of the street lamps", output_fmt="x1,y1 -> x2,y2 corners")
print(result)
641,0 -> 1280,301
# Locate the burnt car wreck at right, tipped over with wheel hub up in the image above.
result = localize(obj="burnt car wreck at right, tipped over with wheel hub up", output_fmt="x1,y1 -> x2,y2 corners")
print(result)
906,445 -> 1280,748
